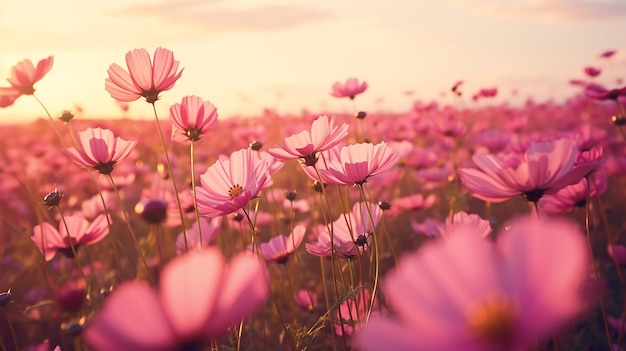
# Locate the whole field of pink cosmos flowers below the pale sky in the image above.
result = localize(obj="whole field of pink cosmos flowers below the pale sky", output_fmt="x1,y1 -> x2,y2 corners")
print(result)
0,48 -> 626,351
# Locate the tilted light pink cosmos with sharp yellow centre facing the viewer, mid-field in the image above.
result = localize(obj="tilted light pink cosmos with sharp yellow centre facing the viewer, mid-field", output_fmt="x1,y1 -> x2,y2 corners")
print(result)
196,149 -> 272,217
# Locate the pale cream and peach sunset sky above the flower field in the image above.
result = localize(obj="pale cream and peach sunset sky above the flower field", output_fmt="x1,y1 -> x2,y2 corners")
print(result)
0,0 -> 626,123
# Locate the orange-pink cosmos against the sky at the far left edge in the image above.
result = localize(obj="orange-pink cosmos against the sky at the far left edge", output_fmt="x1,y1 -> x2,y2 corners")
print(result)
0,56 -> 54,108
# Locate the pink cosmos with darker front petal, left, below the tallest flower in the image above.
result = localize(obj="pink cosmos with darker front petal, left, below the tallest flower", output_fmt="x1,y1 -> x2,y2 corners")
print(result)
65,128 -> 137,174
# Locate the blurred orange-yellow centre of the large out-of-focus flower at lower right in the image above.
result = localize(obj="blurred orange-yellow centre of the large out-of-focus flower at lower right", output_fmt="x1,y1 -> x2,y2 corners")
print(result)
467,294 -> 516,342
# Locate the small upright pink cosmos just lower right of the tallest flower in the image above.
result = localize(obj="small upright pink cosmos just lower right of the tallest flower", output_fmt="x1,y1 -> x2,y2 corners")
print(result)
170,95 -> 217,143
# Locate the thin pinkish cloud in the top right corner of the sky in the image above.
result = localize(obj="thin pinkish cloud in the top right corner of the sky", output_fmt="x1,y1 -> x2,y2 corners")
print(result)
452,0 -> 626,23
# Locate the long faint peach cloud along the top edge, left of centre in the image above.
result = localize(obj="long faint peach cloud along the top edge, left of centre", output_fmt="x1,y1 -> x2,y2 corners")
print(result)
111,0 -> 331,32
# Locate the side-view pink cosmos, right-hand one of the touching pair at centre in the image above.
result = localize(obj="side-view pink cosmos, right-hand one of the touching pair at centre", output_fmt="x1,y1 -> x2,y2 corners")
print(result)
320,141 -> 400,185
